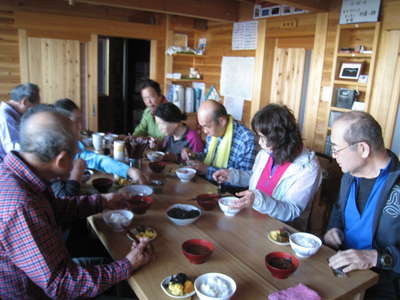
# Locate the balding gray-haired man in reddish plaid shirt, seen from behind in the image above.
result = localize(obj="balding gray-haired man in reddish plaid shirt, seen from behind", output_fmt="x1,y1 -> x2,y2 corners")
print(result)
0,107 -> 152,299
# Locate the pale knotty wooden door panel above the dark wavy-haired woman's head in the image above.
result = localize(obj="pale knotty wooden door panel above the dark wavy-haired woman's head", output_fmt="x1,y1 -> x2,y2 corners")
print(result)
270,48 -> 306,118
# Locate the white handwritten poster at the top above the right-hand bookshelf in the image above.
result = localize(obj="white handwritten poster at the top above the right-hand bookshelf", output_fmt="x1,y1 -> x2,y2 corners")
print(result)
339,0 -> 381,24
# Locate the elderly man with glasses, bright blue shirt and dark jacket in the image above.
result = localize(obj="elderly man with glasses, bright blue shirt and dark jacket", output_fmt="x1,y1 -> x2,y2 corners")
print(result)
324,111 -> 400,299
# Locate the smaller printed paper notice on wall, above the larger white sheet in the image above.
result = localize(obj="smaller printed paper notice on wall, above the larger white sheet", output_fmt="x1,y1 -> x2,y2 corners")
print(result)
232,21 -> 258,50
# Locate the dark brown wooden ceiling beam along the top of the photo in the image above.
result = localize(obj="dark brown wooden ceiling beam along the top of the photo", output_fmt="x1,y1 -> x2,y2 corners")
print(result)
75,0 -> 239,22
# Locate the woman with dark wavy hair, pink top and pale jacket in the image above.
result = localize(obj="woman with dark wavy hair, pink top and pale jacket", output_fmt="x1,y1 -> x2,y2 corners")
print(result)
213,104 -> 321,230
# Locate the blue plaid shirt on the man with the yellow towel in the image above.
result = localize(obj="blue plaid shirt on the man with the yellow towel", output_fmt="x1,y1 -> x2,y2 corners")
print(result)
204,121 -> 256,180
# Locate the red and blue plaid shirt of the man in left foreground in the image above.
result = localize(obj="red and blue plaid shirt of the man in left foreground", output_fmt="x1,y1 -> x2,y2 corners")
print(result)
0,152 -> 133,300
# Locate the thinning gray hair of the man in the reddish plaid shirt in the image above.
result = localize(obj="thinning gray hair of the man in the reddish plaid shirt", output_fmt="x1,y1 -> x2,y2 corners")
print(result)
20,105 -> 77,162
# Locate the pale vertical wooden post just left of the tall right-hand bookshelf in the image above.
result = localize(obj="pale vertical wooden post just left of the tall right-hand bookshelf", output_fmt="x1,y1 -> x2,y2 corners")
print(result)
303,13 -> 328,147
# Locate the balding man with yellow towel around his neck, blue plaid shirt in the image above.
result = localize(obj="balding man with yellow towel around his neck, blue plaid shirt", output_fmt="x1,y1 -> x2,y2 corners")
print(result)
181,100 -> 256,188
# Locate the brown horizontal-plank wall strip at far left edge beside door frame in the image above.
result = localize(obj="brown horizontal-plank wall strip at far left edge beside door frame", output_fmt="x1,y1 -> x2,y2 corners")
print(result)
0,10 -> 20,101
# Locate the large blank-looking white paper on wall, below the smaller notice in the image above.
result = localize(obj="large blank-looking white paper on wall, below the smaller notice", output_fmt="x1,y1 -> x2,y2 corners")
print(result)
220,56 -> 255,100
